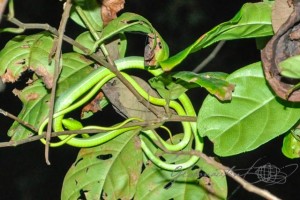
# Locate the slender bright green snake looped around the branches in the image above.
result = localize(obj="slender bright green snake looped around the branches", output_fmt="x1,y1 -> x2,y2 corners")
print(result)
38,57 -> 203,171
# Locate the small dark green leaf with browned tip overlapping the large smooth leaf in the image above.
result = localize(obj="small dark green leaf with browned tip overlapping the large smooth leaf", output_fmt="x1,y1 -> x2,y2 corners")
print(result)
173,71 -> 234,101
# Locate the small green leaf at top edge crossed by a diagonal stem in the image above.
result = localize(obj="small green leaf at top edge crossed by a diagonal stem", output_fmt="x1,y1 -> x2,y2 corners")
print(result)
70,0 -> 103,31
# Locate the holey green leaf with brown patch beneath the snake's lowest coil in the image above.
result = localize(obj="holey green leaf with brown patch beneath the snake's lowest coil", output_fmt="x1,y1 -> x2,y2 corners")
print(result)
134,134 -> 227,200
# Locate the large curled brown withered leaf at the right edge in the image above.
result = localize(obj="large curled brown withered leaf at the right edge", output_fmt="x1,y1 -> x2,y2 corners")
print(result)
261,0 -> 300,102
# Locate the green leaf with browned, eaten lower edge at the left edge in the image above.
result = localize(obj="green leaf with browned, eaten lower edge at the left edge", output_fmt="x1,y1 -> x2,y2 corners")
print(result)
0,32 -> 54,88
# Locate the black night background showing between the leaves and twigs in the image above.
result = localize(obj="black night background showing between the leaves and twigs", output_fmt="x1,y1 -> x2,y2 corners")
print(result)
0,0 -> 300,200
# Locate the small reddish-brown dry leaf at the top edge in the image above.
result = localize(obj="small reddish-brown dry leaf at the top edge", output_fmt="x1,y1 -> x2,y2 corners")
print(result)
101,0 -> 125,25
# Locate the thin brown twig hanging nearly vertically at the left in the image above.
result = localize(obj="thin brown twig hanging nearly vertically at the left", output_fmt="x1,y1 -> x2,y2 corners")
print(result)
45,0 -> 72,165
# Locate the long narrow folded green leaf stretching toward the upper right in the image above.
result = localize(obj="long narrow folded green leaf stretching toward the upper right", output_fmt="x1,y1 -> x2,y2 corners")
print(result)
160,2 -> 273,71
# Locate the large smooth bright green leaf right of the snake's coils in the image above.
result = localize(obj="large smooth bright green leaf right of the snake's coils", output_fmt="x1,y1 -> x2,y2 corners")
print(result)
197,63 -> 300,156
